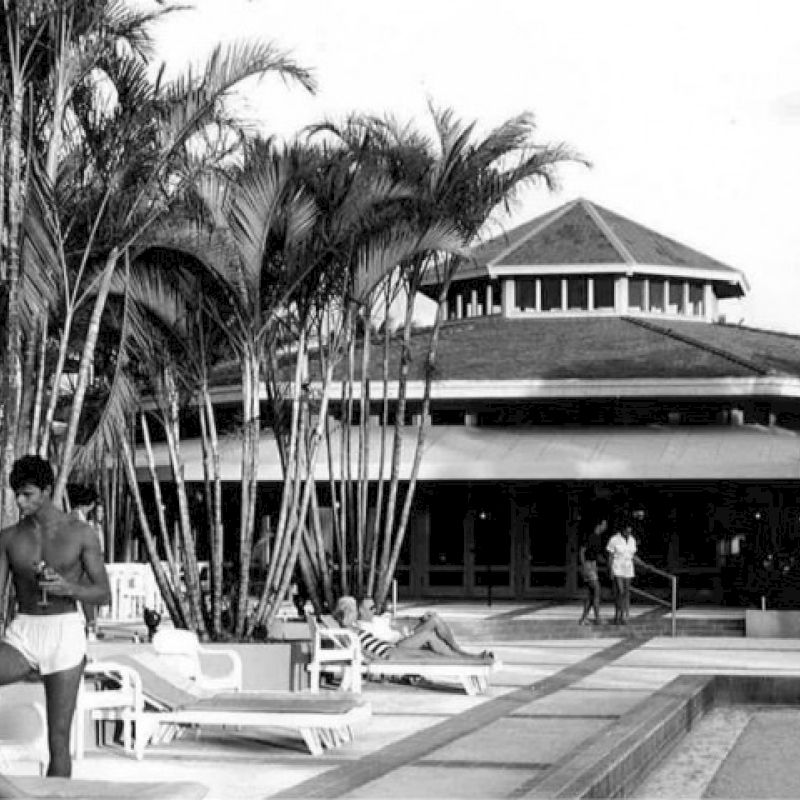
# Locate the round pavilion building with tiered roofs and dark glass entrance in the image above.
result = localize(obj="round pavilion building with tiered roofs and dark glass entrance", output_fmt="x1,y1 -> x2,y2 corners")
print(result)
147,199 -> 800,602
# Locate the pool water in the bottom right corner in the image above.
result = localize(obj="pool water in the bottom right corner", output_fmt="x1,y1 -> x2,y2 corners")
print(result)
631,706 -> 800,800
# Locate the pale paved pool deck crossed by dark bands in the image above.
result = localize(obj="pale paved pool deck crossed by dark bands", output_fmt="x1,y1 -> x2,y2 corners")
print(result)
9,602 -> 800,799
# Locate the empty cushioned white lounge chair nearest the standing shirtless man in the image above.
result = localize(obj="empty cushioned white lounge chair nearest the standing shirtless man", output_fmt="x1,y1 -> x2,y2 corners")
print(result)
83,652 -> 371,758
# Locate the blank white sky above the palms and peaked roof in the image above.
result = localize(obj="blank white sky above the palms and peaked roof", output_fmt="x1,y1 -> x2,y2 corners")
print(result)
148,0 -> 800,334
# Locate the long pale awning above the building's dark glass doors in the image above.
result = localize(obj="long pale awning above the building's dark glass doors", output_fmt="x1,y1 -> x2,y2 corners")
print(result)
138,425 -> 800,481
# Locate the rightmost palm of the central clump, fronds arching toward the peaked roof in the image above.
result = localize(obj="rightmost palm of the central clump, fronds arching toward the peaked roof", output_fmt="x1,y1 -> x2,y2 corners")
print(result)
312,106 -> 577,602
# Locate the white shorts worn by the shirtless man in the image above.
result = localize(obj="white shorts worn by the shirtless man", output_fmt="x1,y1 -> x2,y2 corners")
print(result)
3,611 -> 86,675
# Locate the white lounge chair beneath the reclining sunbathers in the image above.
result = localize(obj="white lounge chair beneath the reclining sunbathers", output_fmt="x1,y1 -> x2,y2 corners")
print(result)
308,617 -> 501,695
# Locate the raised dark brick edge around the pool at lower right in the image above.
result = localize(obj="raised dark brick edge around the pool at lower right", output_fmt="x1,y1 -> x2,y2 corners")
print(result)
525,674 -> 800,798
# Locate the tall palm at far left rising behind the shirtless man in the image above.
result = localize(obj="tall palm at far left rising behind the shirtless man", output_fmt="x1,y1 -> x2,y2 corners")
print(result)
2,0 -> 313,524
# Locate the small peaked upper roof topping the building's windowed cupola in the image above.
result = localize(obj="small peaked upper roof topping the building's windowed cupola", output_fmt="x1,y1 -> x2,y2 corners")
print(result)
428,198 -> 742,280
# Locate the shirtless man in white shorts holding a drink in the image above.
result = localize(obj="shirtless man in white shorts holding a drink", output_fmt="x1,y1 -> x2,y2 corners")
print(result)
0,456 -> 111,778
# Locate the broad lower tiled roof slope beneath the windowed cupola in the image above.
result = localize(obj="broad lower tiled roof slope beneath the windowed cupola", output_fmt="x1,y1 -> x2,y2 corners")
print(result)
352,317 -> 800,382
